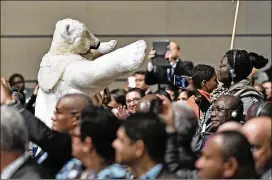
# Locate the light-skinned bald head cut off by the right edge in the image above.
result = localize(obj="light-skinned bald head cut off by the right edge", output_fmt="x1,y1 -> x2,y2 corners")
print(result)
242,116 -> 272,173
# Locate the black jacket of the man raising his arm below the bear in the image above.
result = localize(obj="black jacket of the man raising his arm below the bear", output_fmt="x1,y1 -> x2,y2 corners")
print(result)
15,104 -> 72,175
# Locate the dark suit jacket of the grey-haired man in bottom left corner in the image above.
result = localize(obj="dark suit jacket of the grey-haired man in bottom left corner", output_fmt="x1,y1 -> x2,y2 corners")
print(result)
10,157 -> 51,179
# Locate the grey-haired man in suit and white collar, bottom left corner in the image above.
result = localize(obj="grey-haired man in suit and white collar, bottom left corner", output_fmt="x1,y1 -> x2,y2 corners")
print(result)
0,105 -> 52,179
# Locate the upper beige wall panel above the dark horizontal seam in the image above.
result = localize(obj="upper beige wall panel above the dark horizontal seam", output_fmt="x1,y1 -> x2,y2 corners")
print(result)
1,1 -> 271,34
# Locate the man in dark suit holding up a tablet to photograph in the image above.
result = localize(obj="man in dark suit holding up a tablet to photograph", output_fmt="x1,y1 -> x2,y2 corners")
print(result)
145,41 -> 194,89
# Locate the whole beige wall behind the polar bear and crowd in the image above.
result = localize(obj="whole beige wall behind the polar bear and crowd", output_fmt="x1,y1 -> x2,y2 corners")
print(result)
1,0 -> 271,88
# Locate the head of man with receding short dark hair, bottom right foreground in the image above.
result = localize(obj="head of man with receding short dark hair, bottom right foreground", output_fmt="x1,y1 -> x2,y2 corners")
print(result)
196,131 -> 256,179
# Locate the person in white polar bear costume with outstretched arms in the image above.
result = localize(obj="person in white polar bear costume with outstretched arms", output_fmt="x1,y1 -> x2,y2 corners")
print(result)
35,19 -> 146,128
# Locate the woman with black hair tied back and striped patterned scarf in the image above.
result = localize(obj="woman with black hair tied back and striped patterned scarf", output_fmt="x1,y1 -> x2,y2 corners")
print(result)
191,49 -> 268,154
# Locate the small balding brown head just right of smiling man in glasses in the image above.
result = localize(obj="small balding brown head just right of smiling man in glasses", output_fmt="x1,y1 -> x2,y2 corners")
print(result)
136,94 -> 160,112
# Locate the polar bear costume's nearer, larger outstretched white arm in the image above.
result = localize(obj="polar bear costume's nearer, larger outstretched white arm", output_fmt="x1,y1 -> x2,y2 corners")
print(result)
63,40 -> 146,90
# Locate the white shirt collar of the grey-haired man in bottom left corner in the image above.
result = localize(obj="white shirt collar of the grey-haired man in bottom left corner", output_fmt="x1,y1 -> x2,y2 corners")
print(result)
1,153 -> 29,179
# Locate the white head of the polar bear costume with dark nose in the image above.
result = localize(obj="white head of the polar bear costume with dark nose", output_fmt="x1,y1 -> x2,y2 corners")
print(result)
50,19 -> 100,55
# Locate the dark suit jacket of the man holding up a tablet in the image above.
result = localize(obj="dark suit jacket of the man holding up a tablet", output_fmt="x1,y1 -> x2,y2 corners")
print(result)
145,60 -> 194,85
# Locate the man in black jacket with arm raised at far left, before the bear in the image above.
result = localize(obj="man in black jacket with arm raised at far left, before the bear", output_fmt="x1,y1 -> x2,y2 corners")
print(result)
1,78 -> 94,176
